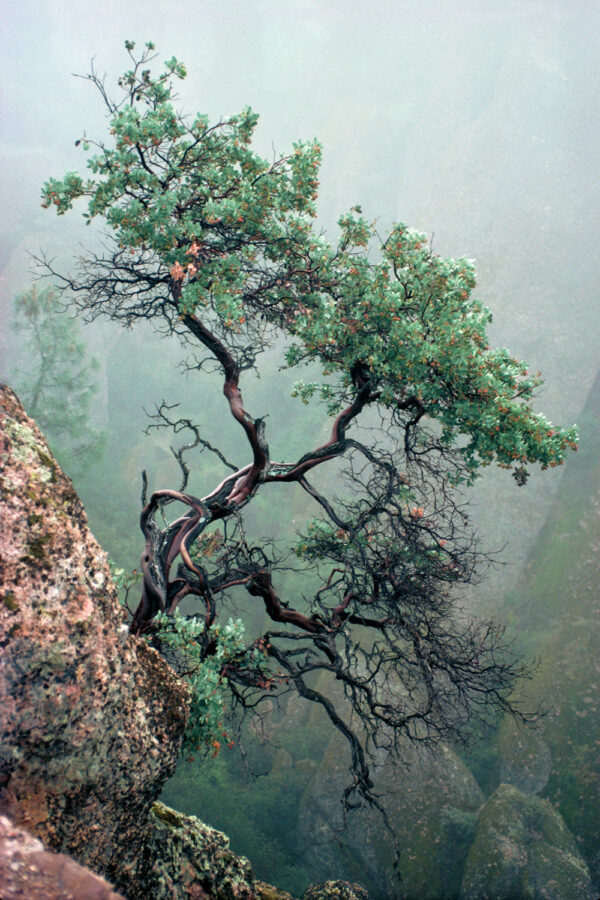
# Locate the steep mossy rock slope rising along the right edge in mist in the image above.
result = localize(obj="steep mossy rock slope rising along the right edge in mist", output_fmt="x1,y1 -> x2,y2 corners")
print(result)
499,364 -> 600,884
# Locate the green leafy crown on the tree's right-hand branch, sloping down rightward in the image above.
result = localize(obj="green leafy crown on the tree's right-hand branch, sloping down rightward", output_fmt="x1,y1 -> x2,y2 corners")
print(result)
288,219 -> 577,480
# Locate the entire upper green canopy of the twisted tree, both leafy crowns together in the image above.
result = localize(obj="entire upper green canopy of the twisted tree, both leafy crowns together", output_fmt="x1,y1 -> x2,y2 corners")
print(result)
43,41 -> 577,482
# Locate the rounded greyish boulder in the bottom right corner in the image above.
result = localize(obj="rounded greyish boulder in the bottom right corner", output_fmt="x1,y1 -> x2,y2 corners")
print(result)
460,784 -> 591,900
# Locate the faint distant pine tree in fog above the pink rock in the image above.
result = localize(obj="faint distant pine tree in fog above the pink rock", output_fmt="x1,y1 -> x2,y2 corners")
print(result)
13,286 -> 104,472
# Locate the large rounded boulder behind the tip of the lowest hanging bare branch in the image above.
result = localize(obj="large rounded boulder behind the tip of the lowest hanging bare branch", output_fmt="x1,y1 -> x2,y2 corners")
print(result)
300,734 -> 484,900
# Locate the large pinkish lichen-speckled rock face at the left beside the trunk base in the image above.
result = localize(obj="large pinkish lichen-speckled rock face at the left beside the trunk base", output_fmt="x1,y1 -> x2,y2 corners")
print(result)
0,386 -> 188,885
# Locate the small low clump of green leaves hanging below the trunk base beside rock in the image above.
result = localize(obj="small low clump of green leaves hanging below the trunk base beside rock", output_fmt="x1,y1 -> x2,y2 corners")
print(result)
151,611 -> 266,755
